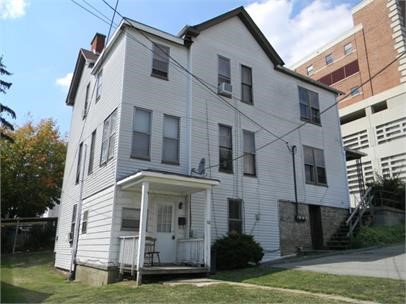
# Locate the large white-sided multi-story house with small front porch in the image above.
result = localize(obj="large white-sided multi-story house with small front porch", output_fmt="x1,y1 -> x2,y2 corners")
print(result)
55,7 -> 349,284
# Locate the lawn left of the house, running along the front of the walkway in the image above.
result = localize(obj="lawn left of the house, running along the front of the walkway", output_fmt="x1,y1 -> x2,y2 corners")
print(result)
1,253 -> 346,304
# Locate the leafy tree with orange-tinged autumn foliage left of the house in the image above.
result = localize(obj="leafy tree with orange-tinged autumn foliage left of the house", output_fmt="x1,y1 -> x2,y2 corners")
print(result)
1,119 -> 66,218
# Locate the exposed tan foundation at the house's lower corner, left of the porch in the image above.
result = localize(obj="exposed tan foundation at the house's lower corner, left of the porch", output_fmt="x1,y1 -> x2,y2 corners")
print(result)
75,265 -> 119,286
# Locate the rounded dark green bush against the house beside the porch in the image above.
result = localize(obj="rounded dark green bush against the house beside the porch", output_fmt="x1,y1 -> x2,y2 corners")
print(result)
213,233 -> 264,270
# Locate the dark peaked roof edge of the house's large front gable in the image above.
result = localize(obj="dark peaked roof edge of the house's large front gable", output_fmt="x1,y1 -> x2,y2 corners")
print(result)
179,6 -> 284,66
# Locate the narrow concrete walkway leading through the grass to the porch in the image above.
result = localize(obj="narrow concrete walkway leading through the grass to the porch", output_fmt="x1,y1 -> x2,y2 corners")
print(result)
164,279 -> 376,304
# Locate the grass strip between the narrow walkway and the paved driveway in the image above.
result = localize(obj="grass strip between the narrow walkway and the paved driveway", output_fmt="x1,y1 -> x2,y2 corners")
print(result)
213,267 -> 406,304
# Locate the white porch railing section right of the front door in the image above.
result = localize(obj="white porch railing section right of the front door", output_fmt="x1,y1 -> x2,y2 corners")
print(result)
176,238 -> 204,265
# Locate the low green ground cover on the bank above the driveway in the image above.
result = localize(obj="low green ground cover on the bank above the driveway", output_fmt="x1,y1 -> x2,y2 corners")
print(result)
352,225 -> 405,248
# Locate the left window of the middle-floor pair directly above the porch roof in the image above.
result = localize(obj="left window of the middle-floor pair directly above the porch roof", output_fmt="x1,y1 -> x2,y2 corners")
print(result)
131,108 -> 151,160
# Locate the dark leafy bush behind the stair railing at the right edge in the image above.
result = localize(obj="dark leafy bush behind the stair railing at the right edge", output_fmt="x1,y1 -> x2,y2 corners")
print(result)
368,175 -> 405,210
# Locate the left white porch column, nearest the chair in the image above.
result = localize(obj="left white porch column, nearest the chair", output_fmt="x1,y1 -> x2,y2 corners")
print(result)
137,182 -> 149,285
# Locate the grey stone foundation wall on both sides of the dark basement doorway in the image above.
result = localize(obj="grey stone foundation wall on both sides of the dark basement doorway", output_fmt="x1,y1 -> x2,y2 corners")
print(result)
279,201 -> 348,255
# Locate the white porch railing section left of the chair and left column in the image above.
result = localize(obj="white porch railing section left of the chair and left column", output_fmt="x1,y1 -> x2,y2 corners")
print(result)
118,236 -> 138,275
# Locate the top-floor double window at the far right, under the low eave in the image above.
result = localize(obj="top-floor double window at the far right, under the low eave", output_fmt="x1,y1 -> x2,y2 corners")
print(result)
299,87 -> 320,124
